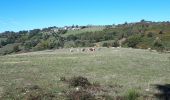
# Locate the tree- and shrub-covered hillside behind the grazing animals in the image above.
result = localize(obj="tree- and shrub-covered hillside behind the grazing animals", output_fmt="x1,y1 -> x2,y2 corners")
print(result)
0,20 -> 170,55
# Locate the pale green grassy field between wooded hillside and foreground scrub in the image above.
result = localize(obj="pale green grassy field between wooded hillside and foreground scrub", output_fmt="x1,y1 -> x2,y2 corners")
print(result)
0,48 -> 170,99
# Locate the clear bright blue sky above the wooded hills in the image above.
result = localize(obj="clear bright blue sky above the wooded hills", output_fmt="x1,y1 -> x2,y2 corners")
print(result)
0,0 -> 170,32
